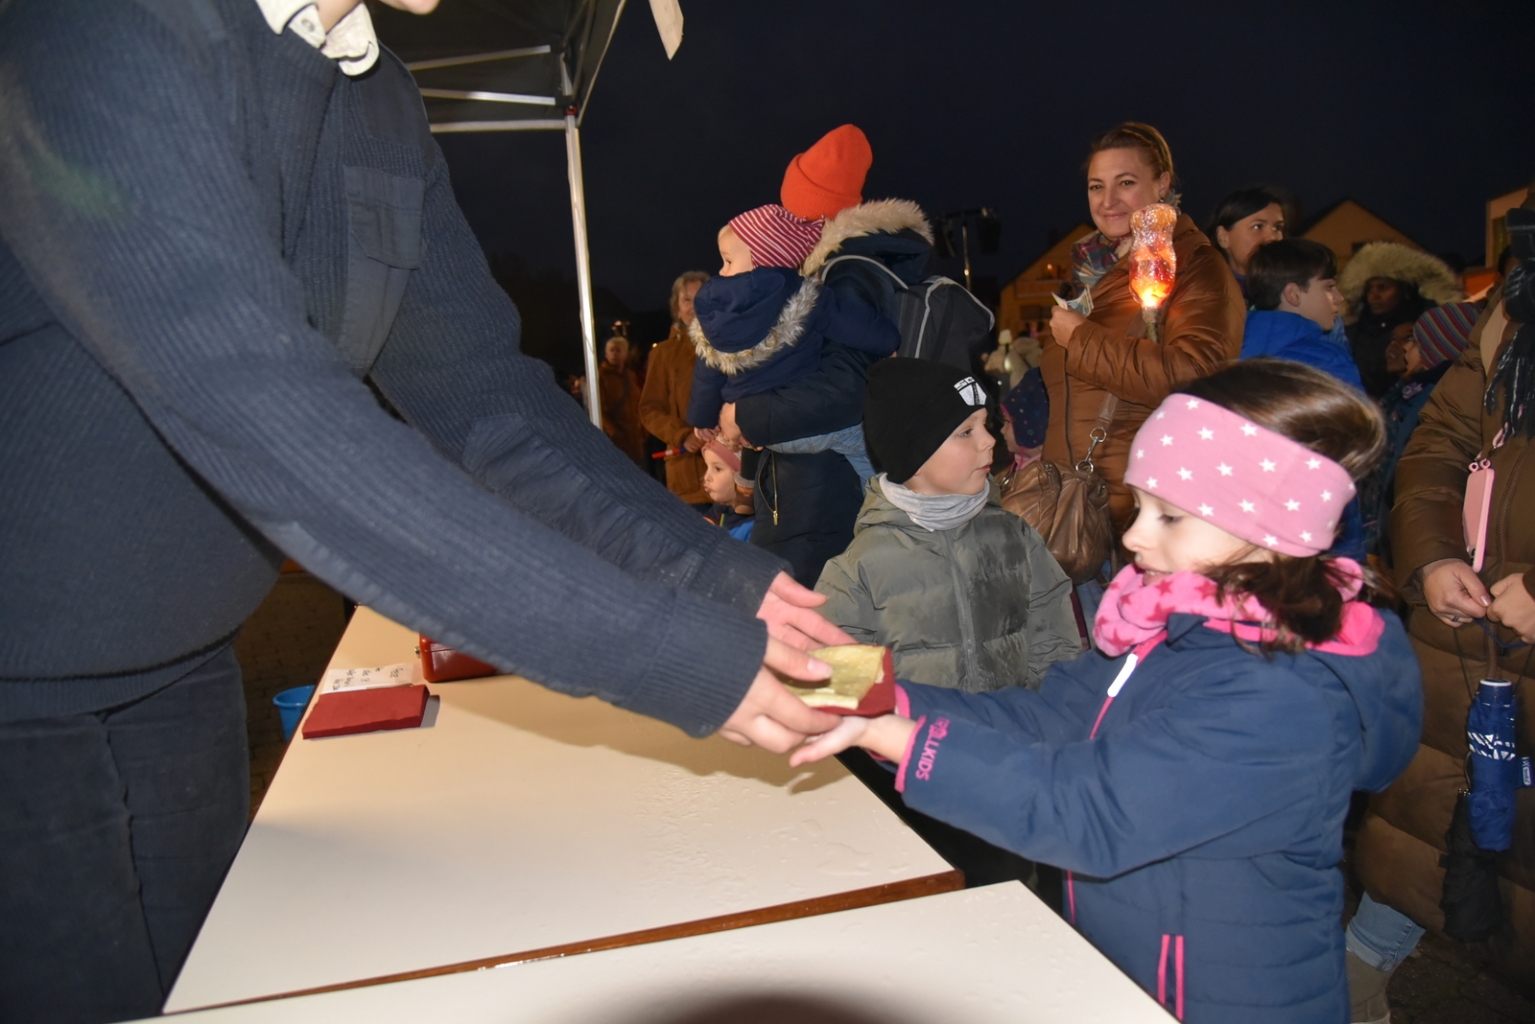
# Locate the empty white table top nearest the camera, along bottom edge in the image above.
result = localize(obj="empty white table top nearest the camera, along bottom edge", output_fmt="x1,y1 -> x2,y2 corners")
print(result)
152,883 -> 1173,1024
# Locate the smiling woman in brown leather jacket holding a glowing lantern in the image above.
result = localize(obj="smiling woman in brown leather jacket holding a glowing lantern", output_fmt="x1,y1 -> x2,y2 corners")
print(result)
1039,123 -> 1246,531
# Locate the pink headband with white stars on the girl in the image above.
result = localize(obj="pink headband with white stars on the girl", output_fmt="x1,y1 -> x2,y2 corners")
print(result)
1125,395 -> 1354,557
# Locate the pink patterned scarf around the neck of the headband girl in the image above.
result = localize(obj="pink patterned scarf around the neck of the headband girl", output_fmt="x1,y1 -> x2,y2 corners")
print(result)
1093,559 -> 1386,657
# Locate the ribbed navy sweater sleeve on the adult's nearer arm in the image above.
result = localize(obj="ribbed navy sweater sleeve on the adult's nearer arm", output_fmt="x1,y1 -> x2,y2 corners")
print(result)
0,0 -> 771,734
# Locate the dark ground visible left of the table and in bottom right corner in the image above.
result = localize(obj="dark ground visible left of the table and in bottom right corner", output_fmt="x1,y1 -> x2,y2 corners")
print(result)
235,573 -> 1535,1024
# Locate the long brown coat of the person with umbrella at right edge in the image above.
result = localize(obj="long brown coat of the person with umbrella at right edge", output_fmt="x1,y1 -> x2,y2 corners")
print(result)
1355,297 -> 1535,983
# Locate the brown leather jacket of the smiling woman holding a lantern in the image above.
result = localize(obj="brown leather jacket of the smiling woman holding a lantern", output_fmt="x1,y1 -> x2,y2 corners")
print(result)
1039,215 -> 1246,530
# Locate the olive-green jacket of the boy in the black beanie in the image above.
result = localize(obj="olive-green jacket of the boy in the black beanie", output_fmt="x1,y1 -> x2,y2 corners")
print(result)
815,477 -> 1082,692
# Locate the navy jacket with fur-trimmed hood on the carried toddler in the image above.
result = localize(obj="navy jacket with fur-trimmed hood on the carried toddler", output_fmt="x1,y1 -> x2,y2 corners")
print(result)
688,267 -> 901,429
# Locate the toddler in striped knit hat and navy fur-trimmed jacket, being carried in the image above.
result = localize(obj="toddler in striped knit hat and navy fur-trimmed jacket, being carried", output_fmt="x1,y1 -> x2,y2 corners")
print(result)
688,206 -> 901,484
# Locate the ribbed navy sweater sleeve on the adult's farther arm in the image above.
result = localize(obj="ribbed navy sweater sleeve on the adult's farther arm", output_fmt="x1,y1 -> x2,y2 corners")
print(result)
371,154 -> 781,614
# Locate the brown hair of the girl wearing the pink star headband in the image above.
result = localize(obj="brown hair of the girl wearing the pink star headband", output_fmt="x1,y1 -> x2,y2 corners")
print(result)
1179,359 -> 1392,652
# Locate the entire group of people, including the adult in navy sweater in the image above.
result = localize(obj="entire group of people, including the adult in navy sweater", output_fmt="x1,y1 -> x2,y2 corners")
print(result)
0,0 -> 1535,1024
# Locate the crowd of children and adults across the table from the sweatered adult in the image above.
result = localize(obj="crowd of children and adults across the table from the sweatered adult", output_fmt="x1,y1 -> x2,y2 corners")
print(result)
626,123 -> 1535,1021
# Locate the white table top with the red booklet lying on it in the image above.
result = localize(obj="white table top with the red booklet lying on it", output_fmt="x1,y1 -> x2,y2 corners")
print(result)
166,608 -> 952,1012
